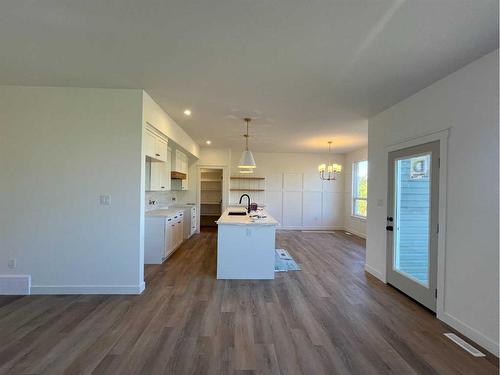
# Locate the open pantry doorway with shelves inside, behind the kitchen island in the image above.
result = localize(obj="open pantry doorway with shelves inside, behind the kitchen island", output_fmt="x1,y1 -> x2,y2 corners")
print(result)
200,168 -> 224,227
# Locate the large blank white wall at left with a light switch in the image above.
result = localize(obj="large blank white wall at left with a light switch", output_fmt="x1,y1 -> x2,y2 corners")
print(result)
0,87 -> 144,293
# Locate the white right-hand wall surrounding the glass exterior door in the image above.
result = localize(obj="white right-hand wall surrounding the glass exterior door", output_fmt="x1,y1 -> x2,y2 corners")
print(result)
366,51 -> 499,355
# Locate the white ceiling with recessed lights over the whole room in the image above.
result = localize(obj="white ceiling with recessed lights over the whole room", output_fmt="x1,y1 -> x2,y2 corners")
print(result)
0,0 -> 498,152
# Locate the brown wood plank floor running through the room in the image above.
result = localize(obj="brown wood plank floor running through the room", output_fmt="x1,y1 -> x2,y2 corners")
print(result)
0,230 -> 498,375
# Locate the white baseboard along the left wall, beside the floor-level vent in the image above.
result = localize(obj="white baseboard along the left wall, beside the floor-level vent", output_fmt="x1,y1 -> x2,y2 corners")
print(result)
31,282 -> 146,295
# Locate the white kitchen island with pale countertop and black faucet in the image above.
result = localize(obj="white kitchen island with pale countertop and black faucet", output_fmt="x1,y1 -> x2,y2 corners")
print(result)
217,207 -> 279,280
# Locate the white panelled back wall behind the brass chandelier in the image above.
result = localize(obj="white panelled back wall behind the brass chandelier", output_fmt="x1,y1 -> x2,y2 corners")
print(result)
230,152 -> 345,229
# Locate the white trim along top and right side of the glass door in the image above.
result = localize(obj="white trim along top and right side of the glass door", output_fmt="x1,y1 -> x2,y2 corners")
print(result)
384,128 -> 449,321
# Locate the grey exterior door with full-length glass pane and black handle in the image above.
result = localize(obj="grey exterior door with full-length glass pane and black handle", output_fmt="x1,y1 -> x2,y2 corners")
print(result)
386,141 -> 440,312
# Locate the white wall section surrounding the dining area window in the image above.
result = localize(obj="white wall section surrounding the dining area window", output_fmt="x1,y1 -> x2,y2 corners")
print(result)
343,147 -> 370,238
